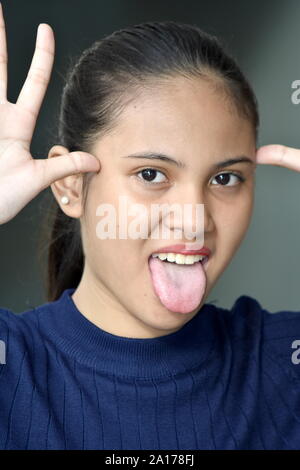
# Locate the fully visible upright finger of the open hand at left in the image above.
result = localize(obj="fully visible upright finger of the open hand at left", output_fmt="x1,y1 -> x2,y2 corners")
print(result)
16,23 -> 55,118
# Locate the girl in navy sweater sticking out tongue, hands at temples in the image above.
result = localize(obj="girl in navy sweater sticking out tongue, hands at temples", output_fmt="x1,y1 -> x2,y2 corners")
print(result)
0,4 -> 300,450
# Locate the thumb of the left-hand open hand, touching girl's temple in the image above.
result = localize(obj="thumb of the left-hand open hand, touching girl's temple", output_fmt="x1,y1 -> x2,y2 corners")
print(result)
32,152 -> 101,190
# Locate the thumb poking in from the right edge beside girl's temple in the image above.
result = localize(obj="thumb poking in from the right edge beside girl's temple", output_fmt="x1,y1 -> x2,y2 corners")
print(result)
256,145 -> 300,171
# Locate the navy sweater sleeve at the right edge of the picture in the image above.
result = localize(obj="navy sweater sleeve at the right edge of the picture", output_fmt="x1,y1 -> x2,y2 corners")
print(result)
228,296 -> 300,449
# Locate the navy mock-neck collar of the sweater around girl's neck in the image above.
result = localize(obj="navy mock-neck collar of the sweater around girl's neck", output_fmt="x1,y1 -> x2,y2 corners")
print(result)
43,288 -> 218,379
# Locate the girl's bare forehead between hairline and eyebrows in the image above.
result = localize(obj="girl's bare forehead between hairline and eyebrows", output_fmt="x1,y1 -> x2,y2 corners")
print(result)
92,77 -> 255,160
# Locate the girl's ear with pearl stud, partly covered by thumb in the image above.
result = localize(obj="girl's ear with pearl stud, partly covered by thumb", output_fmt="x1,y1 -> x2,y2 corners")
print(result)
48,145 -> 83,218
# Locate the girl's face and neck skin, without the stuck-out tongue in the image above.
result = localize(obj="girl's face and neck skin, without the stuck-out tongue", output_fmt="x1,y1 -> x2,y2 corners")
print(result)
62,78 -> 256,338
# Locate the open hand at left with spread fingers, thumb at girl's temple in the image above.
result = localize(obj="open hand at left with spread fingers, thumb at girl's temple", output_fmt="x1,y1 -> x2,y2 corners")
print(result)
0,4 -> 101,224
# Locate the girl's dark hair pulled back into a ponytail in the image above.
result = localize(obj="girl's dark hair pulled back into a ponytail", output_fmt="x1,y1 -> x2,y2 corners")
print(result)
39,21 -> 259,301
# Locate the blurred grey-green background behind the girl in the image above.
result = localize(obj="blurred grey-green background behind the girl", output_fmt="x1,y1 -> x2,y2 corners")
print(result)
0,0 -> 300,313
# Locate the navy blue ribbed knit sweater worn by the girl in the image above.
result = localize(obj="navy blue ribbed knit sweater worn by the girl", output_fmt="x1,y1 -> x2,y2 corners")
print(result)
0,289 -> 300,450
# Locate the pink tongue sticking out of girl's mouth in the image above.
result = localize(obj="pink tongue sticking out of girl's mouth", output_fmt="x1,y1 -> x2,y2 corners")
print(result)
149,257 -> 206,313
